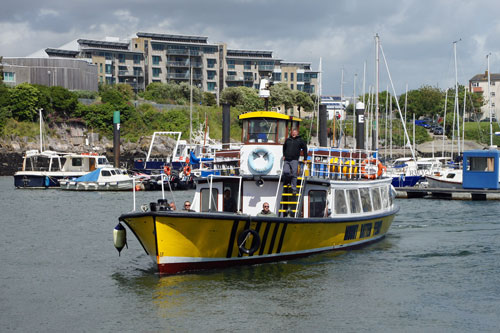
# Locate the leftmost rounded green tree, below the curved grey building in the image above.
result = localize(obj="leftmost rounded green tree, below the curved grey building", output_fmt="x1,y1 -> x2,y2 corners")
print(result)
9,83 -> 40,121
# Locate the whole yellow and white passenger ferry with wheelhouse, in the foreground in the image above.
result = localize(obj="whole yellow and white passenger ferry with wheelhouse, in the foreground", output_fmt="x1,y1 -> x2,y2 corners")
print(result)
114,111 -> 399,274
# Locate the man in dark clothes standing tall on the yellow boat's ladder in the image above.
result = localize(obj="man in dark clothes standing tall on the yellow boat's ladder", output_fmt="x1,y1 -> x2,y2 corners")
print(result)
283,129 -> 307,194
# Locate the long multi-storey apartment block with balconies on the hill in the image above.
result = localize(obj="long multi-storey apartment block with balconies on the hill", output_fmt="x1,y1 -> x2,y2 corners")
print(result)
3,32 -> 318,97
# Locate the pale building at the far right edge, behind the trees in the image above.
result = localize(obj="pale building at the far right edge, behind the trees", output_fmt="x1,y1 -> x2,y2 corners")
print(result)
469,71 -> 500,119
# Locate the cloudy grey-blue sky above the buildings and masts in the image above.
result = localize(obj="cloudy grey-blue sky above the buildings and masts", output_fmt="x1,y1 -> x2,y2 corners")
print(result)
0,0 -> 500,96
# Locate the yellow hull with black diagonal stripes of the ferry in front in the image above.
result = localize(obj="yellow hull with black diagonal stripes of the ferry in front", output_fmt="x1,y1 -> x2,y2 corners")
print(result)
120,208 -> 398,274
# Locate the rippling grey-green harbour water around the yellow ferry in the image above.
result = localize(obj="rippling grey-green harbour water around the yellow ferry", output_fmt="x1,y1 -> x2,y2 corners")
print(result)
0,177 -> 500,332
